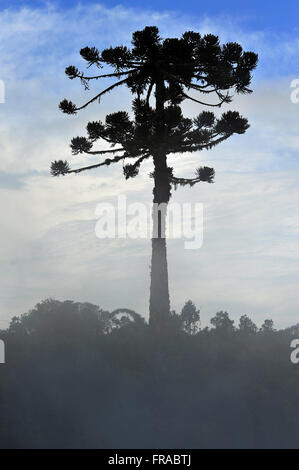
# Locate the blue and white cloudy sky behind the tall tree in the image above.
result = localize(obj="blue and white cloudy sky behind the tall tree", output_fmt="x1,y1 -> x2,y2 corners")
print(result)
0,1 -> 299,328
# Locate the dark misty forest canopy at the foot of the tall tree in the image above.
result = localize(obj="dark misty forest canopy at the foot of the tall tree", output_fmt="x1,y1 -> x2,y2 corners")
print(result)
0,300 -> 299,449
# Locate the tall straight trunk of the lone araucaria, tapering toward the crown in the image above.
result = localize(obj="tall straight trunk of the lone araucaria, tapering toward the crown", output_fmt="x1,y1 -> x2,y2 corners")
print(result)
149,75 -> 171,332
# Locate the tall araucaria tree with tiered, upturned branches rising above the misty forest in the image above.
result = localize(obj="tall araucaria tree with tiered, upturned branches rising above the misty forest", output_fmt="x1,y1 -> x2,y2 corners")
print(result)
51,26 -> 257,330
